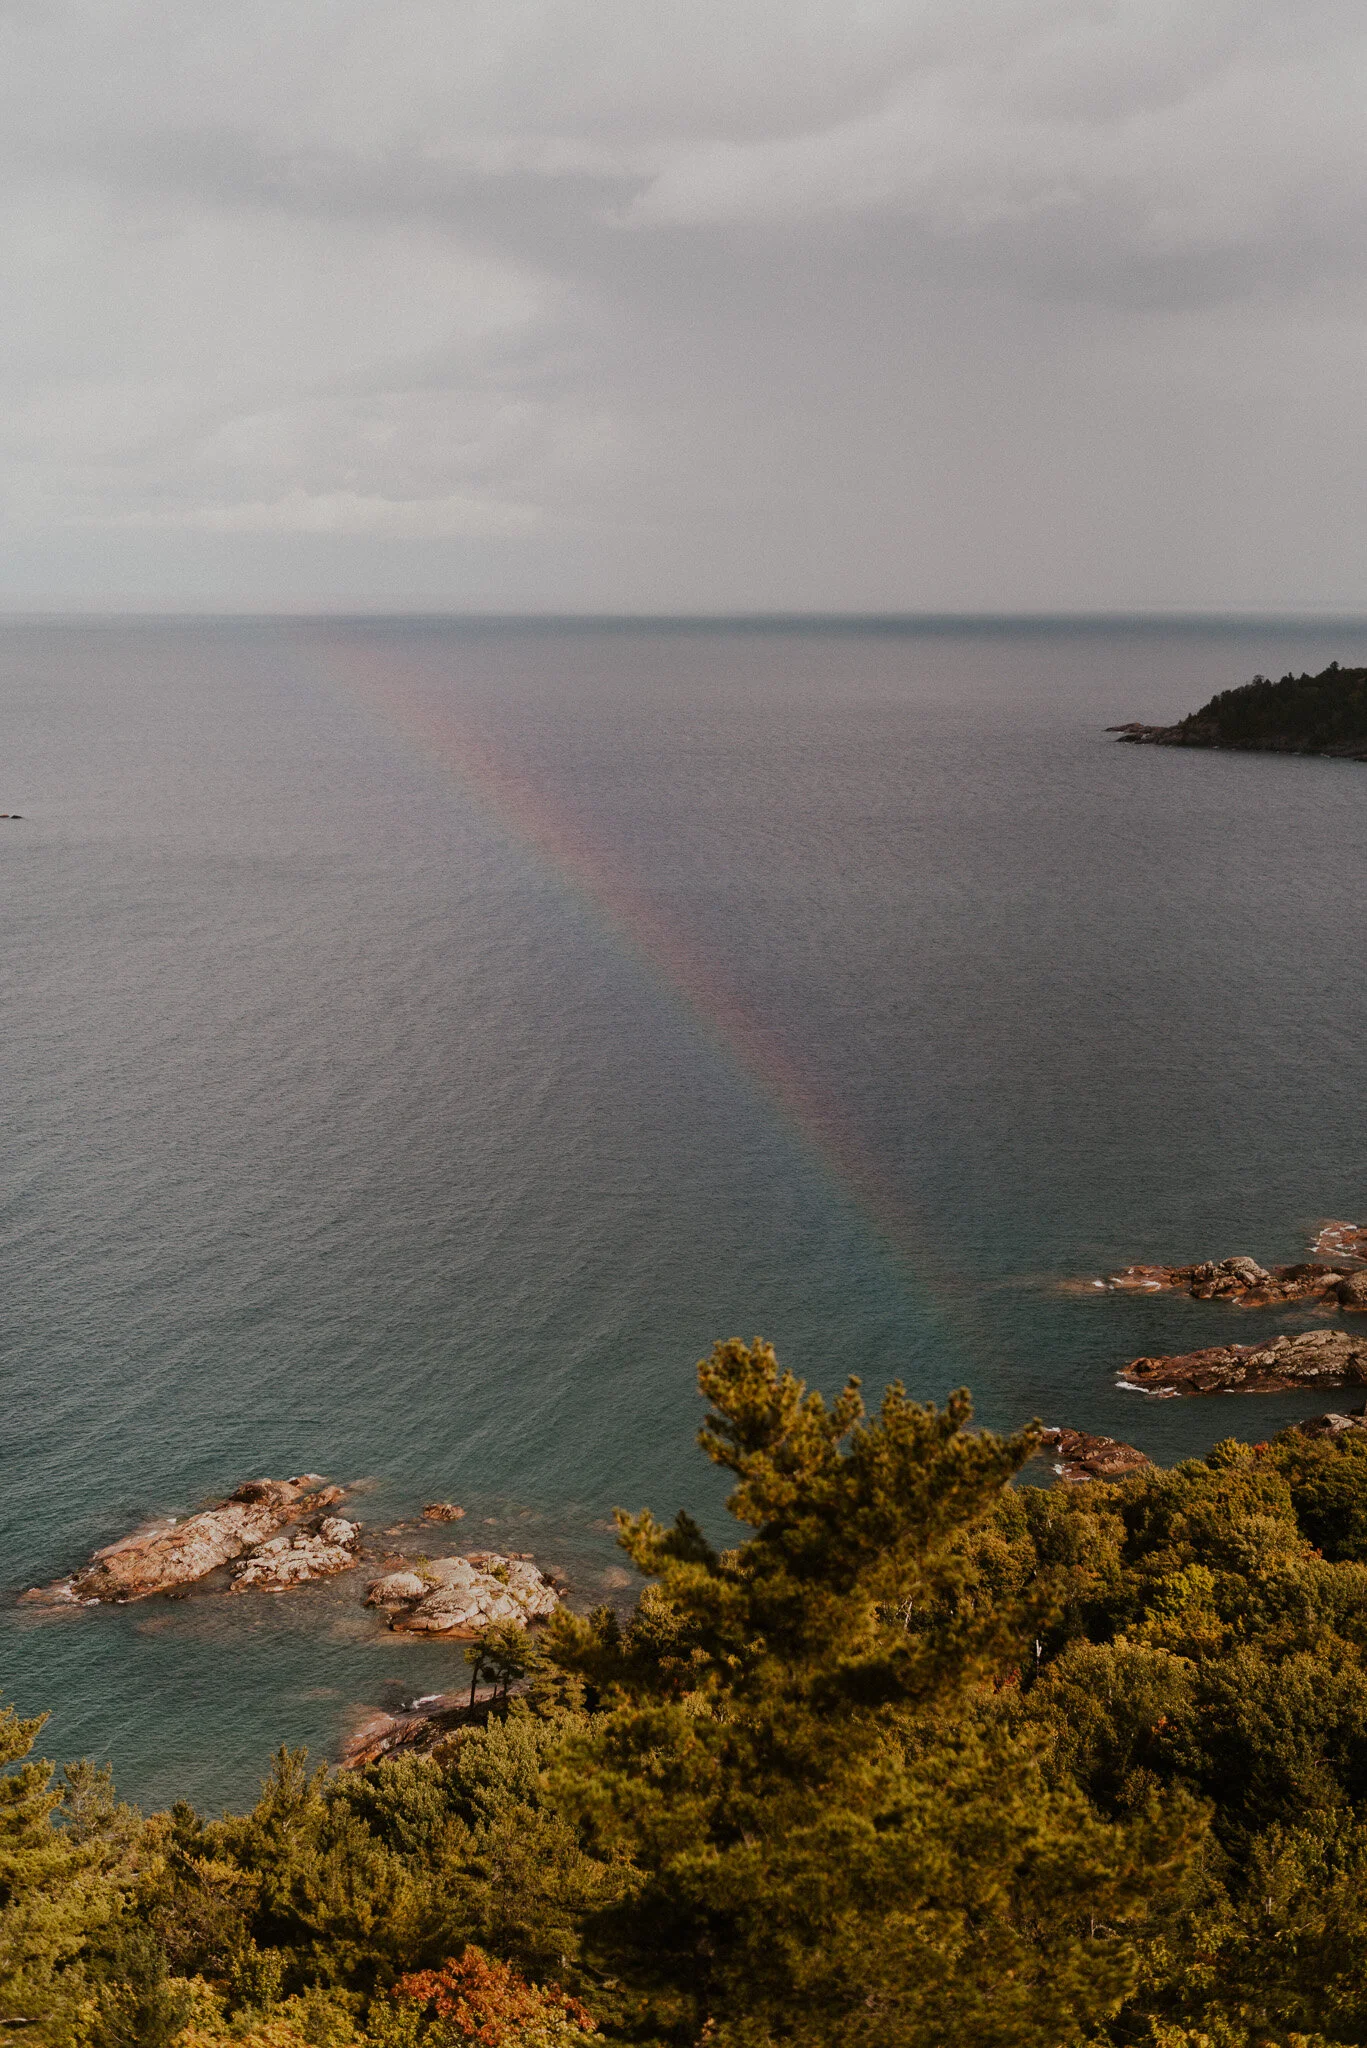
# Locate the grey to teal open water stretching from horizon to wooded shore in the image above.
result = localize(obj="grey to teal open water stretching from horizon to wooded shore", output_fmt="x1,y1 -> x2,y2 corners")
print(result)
0,621 -> 1367,1806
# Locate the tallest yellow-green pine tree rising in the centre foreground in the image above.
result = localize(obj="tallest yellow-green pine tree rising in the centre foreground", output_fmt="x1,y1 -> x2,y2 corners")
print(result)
549,1339 -> 1178,2048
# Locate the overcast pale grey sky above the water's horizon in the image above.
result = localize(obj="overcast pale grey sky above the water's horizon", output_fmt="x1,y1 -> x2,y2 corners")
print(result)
0,0 -> 1367,610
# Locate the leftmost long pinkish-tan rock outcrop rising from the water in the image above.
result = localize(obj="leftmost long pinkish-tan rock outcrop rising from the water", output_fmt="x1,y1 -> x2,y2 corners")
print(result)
23,1473 -> 342,1608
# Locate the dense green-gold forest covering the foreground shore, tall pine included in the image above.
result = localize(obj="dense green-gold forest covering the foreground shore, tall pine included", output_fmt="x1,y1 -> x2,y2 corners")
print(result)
13,1339 -> 1367,2048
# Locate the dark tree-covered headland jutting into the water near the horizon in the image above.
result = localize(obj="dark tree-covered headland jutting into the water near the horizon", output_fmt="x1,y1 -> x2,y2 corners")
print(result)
1107,662 -> 1367,762
